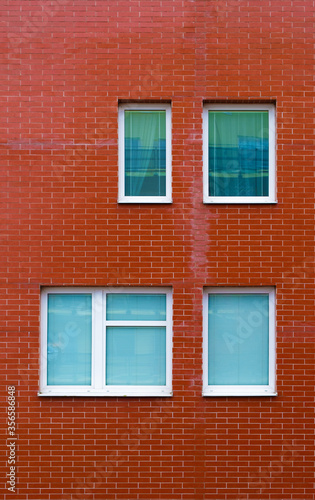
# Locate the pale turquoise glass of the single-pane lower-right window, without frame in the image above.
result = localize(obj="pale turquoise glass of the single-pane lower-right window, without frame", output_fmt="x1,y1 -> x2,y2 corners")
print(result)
208,294 -> 269,385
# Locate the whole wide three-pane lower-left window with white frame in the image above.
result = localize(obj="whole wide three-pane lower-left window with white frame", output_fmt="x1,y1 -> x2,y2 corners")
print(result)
40,288 -> 172,396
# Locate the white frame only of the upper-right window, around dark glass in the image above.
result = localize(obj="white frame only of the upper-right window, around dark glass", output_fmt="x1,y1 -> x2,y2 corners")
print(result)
203,103 -> 277,204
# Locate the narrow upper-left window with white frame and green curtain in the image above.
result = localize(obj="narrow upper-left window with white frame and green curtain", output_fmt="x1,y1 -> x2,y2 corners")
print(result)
119,104 -> 172,203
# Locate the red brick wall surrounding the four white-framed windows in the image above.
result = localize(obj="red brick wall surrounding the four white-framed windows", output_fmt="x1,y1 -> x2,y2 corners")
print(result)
0,0 -> 315,500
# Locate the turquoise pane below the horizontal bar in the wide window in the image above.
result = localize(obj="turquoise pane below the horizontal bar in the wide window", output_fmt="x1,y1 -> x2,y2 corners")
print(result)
106,327 -> 166,385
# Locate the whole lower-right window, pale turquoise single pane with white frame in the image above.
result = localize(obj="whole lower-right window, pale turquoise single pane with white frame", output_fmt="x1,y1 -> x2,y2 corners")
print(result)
203,288 -> 276,396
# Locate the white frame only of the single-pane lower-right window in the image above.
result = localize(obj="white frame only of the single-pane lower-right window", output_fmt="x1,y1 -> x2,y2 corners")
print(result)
203,287 -> 277,396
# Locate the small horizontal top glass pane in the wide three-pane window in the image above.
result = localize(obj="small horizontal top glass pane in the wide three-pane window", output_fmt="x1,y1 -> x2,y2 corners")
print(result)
106,293 -> 166,321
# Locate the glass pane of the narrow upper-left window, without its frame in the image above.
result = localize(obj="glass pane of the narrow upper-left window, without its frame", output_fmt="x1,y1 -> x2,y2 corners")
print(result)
125,110 -> 166,196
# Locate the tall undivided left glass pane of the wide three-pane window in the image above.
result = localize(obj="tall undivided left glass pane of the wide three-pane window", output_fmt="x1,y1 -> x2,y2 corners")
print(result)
47,294 -> 92,385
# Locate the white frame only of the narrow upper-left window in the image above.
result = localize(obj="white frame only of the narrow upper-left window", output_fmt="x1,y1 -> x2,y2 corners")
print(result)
118,103 -> 172,203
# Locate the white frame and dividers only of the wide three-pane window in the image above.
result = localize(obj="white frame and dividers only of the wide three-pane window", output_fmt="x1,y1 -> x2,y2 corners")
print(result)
39,287 -> 172,396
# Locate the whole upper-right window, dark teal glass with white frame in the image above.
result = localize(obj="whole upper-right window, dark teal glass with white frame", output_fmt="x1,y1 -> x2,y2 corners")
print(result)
204,104 -> 276,203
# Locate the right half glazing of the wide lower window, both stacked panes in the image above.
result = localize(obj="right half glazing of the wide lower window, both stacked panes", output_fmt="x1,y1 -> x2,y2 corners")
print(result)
106,293 -> 166,385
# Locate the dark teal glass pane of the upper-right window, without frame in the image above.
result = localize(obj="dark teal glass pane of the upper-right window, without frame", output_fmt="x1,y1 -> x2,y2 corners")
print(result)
209,111 -> 269,196
